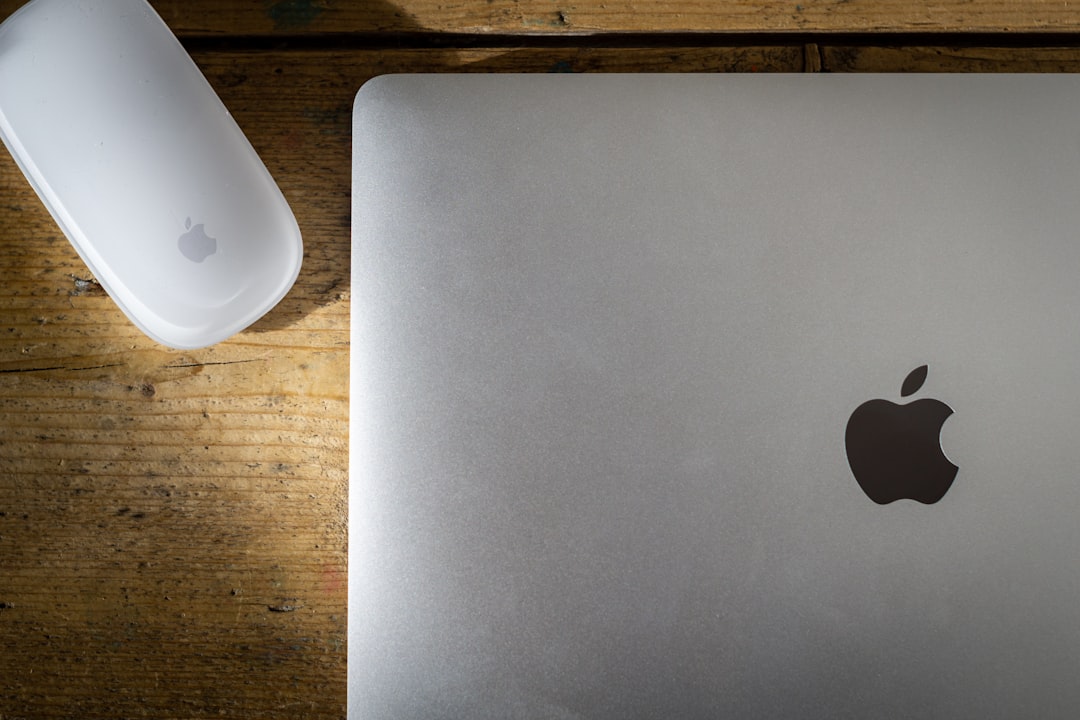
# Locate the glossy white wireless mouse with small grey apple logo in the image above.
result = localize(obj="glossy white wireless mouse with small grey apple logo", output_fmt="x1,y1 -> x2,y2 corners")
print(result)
0,0 -> 303,349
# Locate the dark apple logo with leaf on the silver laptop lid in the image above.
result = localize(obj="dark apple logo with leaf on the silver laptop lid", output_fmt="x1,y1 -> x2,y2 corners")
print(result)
845,365 -> 959,505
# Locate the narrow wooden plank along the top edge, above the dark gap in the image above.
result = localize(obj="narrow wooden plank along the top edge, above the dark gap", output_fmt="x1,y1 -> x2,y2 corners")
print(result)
0,0 -> 1080,37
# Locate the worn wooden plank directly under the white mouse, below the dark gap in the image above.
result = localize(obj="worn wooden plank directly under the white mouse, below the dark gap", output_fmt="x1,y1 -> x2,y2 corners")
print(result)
0,47 -> 802,719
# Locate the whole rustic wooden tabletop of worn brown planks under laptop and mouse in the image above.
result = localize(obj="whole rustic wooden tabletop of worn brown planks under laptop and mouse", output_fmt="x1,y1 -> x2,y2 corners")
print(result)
0,0 -> 1080,720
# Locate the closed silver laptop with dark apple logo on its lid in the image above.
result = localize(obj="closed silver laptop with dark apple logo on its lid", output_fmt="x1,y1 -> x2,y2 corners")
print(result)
348,74 -> 1080,720
